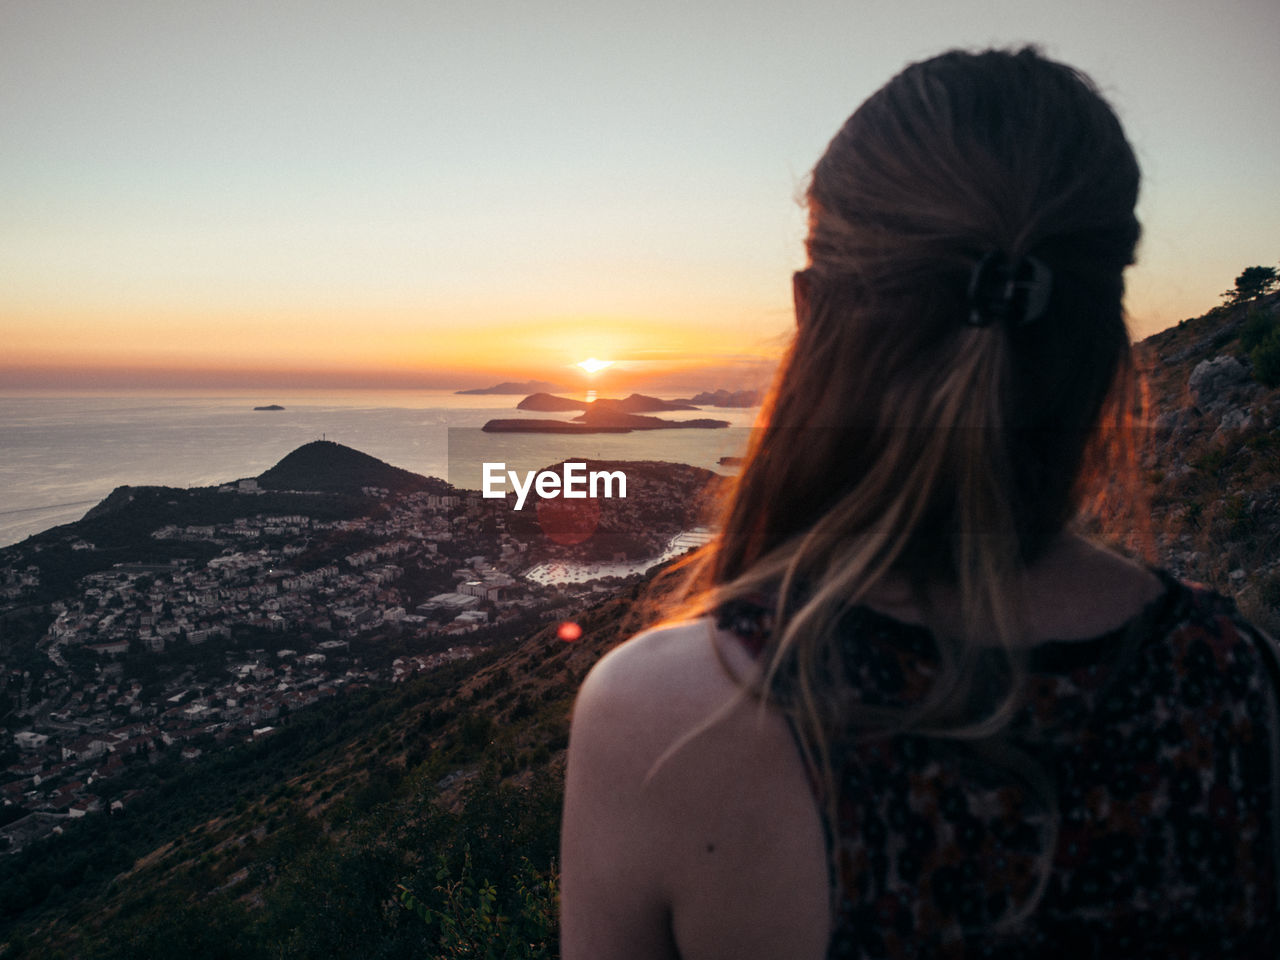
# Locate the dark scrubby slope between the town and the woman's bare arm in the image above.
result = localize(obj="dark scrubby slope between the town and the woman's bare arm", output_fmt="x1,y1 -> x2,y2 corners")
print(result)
0,588 -> 650,960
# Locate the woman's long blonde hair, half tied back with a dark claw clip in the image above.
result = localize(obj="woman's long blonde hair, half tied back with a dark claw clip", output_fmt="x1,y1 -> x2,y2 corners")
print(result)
660,49 -> 1139,926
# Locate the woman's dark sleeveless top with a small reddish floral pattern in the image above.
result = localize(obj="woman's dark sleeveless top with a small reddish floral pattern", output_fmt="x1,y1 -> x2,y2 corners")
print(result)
718,571 -> 1280,960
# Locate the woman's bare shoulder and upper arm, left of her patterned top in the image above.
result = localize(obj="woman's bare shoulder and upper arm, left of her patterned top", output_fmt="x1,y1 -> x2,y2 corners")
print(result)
562,620 -> 827,960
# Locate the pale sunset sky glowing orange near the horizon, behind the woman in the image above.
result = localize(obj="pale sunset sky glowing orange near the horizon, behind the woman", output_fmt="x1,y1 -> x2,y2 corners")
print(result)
0,0 -> 1280,392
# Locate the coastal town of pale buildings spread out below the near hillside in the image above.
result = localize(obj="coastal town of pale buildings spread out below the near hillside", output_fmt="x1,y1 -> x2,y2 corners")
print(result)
0,444 -> 710,851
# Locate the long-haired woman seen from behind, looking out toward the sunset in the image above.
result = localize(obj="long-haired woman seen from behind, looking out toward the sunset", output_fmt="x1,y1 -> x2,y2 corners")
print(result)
562,49 -> 1280,960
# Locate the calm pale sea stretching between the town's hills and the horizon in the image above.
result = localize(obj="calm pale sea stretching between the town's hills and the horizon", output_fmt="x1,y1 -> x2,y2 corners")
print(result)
0,390 -> 758,547
